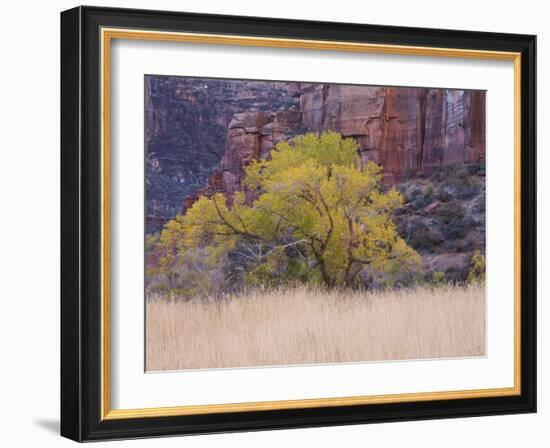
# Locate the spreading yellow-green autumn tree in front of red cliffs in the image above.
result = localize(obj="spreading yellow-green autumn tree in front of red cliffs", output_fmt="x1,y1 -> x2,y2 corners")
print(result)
153,132 -> 420,296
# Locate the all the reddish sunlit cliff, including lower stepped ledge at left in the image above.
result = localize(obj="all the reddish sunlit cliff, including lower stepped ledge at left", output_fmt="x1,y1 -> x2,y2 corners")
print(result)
188,83 -> 485,211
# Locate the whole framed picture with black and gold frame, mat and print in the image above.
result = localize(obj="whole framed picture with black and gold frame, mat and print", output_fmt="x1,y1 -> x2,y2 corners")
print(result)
61,7 -> 536,441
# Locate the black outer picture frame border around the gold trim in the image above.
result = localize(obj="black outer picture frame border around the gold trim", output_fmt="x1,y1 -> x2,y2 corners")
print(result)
61,7 -> 537,442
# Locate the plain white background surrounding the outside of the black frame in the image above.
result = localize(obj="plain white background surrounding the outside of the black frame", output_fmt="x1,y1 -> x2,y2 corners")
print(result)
0,0 -> 550,448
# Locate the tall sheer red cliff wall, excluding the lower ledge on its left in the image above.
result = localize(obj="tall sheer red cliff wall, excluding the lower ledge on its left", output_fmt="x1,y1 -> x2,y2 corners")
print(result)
300,84 -> 485,185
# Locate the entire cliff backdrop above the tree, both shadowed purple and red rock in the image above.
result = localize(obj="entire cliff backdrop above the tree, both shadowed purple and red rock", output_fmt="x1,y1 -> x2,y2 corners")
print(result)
145,76 -> 485,233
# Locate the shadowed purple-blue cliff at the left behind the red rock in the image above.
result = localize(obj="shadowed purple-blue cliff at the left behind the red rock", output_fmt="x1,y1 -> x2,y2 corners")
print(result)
145,75 -> 299,233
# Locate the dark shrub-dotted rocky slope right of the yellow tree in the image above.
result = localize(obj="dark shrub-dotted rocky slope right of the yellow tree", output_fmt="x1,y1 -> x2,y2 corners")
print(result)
394,163 -> 485,281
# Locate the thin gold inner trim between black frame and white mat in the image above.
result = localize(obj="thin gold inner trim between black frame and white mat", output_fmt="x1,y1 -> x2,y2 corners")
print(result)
100,28 -> 521,420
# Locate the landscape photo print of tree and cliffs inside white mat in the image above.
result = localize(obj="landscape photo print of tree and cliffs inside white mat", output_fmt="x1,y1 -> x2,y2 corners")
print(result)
144,75 -> 486,372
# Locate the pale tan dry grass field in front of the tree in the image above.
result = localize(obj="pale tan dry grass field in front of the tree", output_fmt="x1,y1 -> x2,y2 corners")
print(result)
146,286 -> 485,371
